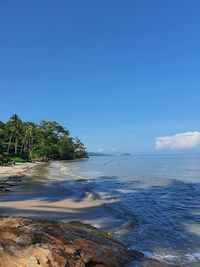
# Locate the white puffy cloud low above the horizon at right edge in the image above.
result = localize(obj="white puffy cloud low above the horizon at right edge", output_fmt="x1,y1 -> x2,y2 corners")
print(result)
155,131 -> 200,149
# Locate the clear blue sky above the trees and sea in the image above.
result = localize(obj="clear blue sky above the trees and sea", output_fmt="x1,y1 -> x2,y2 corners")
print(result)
0,0 -> 200,153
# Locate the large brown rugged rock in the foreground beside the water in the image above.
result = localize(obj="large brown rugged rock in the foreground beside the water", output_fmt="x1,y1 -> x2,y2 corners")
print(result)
0,218 -> 143,267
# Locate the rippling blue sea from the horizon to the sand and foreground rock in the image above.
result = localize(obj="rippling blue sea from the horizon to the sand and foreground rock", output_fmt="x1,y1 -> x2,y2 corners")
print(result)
1,154 -> 200,266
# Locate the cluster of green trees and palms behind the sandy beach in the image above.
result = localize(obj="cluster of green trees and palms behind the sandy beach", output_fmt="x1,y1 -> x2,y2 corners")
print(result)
0,114 -> 88,162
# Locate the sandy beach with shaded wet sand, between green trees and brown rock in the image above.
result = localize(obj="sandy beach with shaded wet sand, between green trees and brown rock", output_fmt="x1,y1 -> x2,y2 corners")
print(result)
0,163 -> 111,226
